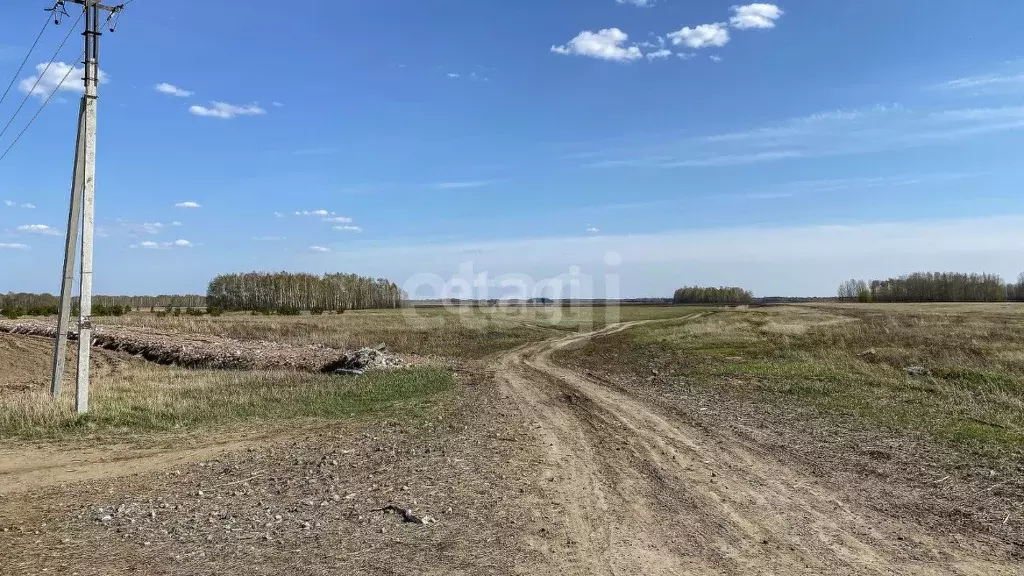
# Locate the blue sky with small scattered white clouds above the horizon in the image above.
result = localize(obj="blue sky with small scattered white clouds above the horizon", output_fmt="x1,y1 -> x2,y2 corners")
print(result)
0,0 -> 1024,296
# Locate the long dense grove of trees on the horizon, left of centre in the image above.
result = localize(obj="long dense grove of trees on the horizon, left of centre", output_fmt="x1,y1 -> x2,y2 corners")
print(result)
206,272 -> 403,312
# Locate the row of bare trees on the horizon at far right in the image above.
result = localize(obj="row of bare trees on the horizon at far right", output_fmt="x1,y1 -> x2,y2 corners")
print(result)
838,272 -> 1024,302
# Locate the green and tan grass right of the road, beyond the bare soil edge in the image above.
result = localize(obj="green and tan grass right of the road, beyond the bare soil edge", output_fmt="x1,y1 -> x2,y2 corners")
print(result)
581,305 -> 1024,458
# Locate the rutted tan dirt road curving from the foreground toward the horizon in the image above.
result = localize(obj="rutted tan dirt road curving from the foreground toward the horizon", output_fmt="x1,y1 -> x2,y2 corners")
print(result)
497,323 -> 1022,576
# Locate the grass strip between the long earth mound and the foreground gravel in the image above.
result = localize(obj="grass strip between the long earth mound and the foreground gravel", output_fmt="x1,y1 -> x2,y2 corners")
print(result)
0,366 -> 455,439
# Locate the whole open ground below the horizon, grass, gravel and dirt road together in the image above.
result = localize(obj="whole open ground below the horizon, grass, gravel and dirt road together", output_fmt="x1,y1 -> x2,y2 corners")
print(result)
0,304 -> 1024,575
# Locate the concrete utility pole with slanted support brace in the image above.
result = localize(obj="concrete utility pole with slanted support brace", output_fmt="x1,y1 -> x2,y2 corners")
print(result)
50,0 -> 124,414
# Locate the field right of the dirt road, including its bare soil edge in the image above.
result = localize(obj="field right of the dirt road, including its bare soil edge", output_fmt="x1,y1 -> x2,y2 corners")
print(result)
558,303 -> 1024,543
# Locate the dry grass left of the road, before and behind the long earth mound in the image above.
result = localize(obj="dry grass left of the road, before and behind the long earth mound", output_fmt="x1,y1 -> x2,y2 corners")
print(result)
0,306 -> 688,438
